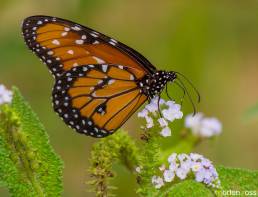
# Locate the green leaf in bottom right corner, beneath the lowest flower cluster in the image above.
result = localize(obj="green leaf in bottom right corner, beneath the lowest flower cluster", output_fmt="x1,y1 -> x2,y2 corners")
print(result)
158,166 -> 258,197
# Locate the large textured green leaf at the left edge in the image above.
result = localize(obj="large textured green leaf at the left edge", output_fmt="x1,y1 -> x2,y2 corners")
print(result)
0,88 -> 63,197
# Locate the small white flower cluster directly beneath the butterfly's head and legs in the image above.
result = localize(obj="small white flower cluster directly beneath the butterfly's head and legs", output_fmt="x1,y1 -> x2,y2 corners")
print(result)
138,97 -> 183,137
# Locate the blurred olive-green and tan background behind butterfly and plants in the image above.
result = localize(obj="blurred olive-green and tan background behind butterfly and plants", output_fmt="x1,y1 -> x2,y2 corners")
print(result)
0,0 -> 258,196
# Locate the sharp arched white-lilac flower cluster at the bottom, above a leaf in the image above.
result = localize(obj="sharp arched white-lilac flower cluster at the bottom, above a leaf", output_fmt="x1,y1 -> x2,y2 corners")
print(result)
152,153 -> 220,189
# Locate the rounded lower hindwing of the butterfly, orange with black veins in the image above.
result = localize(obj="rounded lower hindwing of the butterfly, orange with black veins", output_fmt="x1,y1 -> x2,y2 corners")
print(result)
52,64 -> 147,138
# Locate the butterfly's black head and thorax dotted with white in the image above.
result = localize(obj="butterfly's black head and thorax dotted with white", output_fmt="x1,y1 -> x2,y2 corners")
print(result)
139,71 -> 176,99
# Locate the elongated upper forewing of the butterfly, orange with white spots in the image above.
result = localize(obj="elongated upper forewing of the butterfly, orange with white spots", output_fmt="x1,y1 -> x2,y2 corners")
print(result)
22,16 -> 155,77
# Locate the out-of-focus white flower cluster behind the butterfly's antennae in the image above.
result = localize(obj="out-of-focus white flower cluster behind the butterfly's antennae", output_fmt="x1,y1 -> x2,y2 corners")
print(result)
185,113 -> 222,137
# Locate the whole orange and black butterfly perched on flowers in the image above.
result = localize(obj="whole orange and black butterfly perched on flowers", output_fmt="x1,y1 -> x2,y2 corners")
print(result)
22,16 -> 199,138
